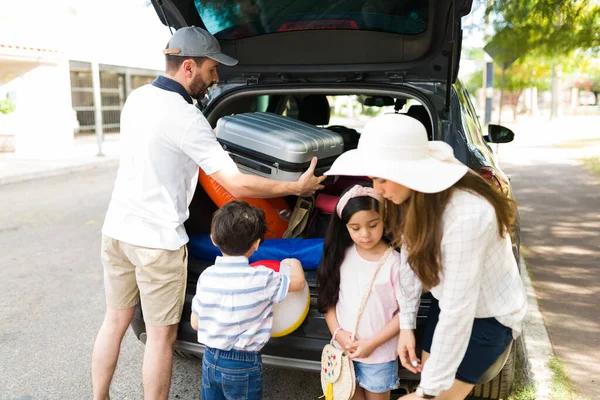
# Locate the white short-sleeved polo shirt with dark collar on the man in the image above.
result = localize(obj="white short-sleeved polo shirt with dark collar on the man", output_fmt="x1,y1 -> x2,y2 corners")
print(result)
102,77 -> 237,250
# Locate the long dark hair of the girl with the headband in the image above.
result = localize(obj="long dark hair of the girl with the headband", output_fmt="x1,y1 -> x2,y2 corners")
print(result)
317,184 -> 379,314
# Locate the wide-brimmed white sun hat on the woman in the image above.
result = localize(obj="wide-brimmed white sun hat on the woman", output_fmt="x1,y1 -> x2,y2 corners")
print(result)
325,114 -> 469,193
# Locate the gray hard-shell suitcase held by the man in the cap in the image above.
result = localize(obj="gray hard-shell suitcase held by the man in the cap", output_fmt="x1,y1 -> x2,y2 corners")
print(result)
215,112 -> 344,180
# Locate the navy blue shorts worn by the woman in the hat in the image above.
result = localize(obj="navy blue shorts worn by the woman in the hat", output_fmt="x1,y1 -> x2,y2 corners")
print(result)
422,297 -> 513,385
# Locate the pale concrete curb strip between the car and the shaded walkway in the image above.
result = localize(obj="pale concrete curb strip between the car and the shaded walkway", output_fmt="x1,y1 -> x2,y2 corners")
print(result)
517,257 -> 554,400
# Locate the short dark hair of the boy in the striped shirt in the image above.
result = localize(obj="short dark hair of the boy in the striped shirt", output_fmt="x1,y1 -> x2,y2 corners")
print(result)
210,200 -> 267,256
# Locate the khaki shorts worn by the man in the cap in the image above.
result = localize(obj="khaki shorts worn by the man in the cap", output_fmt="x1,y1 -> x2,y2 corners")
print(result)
101,235 -> 188,326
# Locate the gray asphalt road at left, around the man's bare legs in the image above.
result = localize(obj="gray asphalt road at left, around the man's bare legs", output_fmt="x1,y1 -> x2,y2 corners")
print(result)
0,167 -> 321,400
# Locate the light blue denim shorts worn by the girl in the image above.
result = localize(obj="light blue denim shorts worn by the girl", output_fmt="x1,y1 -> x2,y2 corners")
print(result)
354,359 -> 400,393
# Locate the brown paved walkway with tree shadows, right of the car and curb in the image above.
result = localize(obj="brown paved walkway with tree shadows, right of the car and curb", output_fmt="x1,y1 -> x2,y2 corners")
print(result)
500,120 -> 600,399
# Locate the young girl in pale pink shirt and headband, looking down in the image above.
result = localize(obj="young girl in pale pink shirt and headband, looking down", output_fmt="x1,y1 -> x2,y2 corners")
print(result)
317,185 -> 421,400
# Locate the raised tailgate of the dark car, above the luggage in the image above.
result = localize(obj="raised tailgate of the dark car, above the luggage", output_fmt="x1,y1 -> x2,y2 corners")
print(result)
152,0 -> 472,108
